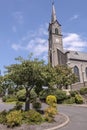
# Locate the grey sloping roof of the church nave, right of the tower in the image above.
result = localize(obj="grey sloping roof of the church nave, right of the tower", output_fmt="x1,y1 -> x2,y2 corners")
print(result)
67,51 -> 87,61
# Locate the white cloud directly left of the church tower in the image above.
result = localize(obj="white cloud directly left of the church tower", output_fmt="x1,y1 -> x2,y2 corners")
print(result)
12,24 -> 48,59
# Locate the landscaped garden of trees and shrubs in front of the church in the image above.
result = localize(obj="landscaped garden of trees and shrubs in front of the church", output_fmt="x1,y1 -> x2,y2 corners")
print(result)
0,57 -> 84,127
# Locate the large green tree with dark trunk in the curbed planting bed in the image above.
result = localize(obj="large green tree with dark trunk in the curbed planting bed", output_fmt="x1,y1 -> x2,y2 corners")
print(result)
6,58 -> 44,110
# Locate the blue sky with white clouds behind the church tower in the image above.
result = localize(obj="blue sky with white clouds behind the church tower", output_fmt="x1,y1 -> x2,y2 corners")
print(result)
0,0 -> 87,73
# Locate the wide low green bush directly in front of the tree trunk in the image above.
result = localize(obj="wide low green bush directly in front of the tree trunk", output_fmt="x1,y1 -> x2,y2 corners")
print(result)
23,110 -> 43,124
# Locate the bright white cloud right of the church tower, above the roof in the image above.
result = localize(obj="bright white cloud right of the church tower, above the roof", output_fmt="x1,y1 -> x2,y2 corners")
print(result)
63,33 -> 87,51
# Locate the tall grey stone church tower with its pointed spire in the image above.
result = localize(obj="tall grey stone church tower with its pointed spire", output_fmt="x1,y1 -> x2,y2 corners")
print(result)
48,2 -> 63,67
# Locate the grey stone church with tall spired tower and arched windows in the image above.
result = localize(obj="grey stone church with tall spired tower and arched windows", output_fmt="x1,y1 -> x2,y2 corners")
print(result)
48,3 -> 87,86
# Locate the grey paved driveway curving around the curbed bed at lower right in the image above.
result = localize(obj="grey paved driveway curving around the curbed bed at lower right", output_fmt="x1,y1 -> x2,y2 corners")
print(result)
56,105 -> 87,130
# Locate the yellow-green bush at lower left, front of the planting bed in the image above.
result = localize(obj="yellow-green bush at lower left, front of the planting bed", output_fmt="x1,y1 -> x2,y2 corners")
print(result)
6,110 -> 22,127
